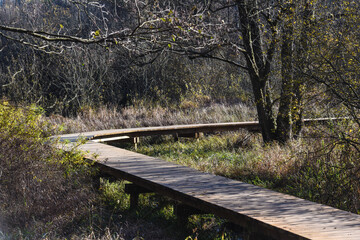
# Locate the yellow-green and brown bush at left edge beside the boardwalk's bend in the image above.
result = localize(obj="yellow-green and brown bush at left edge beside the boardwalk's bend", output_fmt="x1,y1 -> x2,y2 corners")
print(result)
0,101 -> 92,239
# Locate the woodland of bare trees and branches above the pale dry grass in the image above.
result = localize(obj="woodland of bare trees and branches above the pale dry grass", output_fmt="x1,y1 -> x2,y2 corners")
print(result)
0,0 -> 359,142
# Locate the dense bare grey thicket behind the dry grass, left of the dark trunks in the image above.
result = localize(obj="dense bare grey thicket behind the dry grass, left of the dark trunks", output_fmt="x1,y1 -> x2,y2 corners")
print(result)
0,1 -> 251,116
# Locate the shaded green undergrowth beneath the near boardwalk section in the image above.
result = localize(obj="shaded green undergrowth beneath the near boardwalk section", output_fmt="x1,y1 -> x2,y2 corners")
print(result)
97,179 -> 241,240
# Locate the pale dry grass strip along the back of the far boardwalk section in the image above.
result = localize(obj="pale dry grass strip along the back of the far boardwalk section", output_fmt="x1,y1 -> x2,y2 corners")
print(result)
47,104 -> 256,133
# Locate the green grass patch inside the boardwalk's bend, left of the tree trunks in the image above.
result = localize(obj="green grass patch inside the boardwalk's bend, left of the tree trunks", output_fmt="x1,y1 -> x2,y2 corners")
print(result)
138,131 -> 258,176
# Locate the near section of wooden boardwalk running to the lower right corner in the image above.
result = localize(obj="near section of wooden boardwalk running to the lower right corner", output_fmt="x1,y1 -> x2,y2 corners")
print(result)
76,141 -> 360,240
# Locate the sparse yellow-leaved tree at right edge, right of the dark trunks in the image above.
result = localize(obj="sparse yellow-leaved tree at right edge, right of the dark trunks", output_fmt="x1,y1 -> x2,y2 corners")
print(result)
301,1 -> 360,148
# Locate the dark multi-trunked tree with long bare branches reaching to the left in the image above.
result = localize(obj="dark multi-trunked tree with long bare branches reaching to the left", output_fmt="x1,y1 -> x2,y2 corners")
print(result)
0,0 -> 354,142
